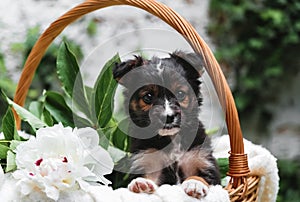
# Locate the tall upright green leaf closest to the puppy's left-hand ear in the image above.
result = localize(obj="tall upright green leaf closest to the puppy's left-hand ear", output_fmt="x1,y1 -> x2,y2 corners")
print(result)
94,54 -> 121,128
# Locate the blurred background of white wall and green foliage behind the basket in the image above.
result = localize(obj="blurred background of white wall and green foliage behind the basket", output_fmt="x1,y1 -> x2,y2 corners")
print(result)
0,0 -> 300,202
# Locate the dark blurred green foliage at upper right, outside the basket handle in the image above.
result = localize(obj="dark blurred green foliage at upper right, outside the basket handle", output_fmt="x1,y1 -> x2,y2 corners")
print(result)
209,0 -> 300,129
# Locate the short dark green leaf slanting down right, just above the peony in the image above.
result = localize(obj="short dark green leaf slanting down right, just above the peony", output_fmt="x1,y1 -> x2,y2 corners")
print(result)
45,91 -> 75,127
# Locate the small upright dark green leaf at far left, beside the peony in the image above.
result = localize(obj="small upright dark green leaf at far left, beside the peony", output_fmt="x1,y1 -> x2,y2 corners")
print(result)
2,107 -> 20,140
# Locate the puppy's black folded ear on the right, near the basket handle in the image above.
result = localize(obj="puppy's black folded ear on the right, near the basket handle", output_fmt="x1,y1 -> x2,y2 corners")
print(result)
170,51 -> 205,77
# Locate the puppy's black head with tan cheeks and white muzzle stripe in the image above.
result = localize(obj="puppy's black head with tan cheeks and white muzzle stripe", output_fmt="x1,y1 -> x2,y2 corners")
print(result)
113,52 -> 203,136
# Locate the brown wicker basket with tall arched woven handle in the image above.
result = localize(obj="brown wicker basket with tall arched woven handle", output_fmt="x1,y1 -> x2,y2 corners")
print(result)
14,0 -> 260,201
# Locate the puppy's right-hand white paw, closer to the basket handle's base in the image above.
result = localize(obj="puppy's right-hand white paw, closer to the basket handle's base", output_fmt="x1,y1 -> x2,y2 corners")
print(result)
181,179 -> 208,199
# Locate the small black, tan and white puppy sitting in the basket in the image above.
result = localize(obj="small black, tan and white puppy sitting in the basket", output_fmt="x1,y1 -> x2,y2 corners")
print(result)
113,51 -> 220,198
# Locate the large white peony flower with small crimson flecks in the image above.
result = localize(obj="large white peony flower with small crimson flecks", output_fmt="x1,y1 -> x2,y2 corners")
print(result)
13,124 -> 113,200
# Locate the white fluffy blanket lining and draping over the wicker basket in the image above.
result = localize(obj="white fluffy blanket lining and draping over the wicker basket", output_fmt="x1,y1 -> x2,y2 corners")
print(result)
0,135 -> 279,202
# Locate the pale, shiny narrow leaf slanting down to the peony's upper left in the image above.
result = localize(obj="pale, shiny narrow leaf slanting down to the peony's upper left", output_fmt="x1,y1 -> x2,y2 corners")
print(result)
6,98 -> 47,129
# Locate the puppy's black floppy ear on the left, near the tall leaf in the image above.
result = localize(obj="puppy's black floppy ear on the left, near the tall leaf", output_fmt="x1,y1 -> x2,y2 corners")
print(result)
113,56 -> 145,84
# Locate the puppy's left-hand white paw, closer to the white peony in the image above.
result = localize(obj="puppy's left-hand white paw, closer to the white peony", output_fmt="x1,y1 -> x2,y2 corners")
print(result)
128,177 -> 157,194
